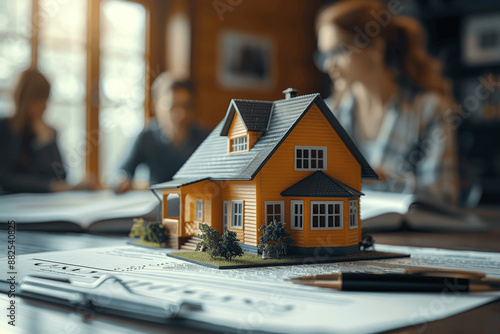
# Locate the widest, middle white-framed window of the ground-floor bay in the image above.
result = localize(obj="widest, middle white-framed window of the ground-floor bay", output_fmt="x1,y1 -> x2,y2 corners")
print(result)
311,201 -> 343,230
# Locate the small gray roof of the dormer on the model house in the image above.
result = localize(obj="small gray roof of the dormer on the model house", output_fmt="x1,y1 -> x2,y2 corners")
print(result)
220,100 -> 273,136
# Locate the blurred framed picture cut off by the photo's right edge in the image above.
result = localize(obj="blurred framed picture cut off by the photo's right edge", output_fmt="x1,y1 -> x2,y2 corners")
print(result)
462,13 -> 500,66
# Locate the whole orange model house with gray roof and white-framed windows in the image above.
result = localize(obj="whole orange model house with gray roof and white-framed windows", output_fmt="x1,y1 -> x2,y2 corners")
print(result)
150,89 -> 378,255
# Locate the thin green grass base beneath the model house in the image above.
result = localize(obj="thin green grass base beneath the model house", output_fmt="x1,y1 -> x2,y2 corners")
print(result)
167,251 -> 409,269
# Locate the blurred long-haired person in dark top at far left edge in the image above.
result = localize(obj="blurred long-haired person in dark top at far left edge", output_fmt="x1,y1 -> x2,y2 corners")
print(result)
0,69 -> 97,193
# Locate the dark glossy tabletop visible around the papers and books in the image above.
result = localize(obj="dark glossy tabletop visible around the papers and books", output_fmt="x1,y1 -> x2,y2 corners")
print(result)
0,208 -> 500,334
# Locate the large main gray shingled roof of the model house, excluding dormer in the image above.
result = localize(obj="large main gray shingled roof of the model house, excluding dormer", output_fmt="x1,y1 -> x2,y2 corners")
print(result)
166,94 -> 378,187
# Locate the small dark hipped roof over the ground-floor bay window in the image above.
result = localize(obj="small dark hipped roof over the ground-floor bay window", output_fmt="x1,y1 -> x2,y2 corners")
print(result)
281,171 -> 363,197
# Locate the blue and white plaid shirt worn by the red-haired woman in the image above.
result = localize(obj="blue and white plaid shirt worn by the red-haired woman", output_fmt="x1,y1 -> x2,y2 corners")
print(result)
327,93 -> 459,203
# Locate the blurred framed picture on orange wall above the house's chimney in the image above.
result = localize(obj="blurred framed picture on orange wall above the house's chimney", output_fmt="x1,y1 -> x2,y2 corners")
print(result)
217,31 -> 275,90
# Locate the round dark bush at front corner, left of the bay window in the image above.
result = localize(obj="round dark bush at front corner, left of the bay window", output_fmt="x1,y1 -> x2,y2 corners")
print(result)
259,221 -> 295,259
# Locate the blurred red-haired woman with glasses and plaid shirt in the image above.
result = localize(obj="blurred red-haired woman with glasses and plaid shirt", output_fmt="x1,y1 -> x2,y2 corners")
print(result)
316,1 -> 459,203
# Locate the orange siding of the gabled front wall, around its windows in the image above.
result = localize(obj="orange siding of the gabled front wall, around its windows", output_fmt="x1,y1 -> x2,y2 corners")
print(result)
257,105 -> 361,247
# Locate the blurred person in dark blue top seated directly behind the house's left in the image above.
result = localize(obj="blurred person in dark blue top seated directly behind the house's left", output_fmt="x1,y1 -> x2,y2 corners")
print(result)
116,72 -> 208,193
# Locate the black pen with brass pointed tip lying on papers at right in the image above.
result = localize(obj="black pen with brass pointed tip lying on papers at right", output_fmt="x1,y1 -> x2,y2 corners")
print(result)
290,272 -> 500,292
